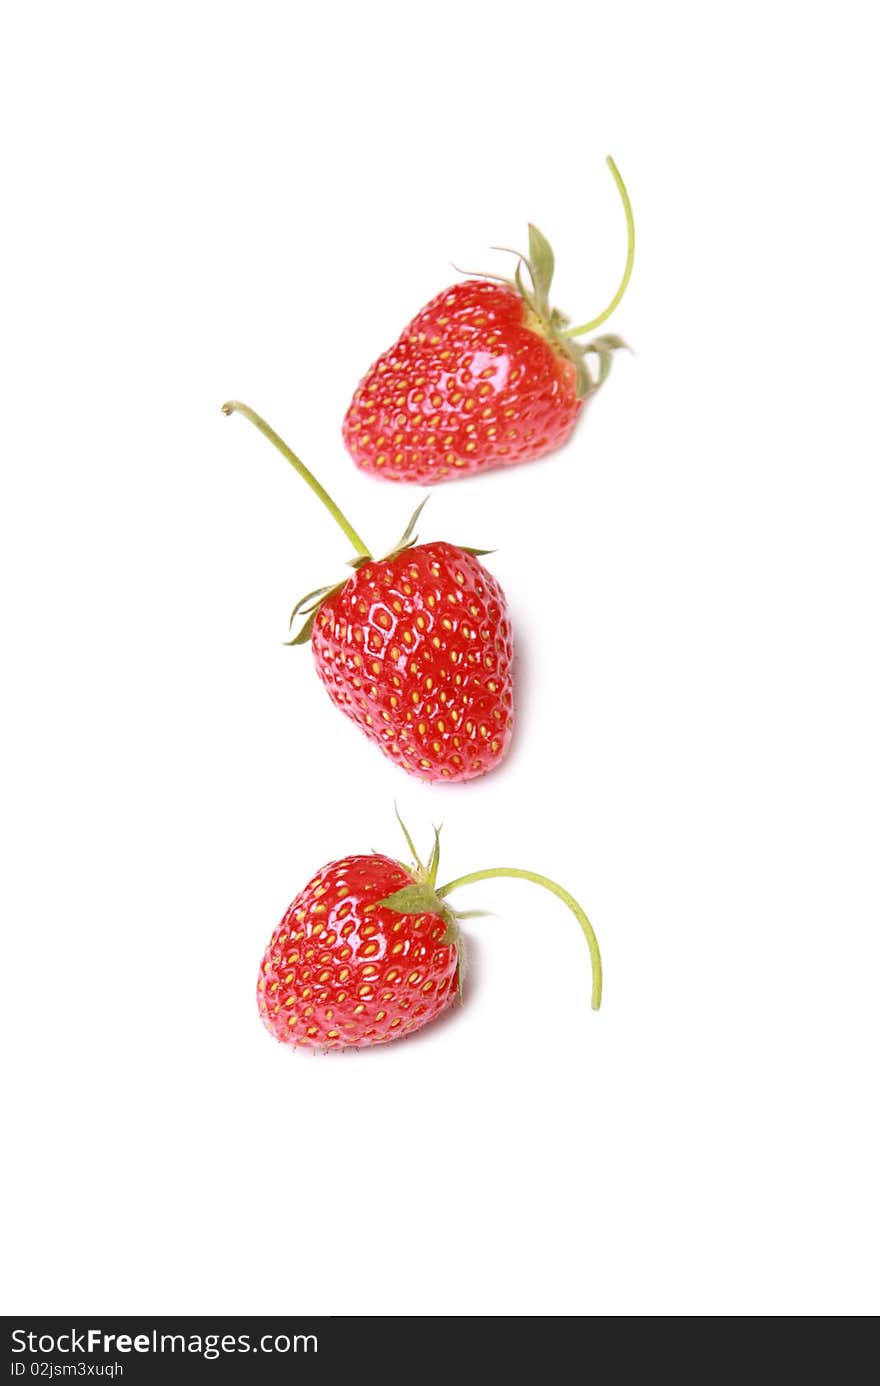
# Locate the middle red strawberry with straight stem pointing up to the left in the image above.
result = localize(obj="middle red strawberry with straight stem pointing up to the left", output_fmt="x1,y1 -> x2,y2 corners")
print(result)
223,401 -> 513,783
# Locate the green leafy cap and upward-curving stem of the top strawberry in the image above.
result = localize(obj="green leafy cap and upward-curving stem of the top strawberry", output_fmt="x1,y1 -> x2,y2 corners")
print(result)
468,155 -> 636,399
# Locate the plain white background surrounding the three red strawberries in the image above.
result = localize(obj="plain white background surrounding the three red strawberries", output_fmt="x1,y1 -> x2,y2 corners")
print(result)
0,0 -> 880,1315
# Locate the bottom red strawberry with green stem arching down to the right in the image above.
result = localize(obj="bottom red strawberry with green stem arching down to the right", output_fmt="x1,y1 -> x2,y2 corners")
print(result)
256,825 -> 601,1049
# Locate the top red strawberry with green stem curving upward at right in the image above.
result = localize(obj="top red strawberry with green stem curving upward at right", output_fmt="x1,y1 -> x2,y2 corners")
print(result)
342,158 -> 635,485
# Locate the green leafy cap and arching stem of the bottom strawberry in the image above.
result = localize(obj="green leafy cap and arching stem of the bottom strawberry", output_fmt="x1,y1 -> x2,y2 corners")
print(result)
378,805 -> 601,1010
